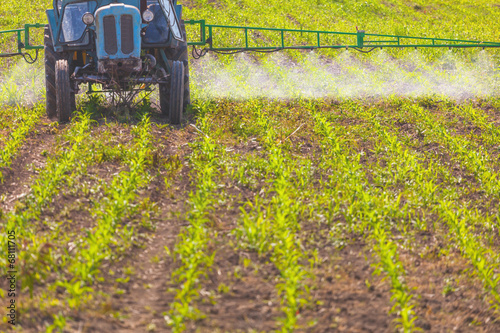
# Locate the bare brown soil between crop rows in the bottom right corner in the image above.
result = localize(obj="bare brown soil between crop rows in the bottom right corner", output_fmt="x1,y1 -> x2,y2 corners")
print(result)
400,232 -> 500,332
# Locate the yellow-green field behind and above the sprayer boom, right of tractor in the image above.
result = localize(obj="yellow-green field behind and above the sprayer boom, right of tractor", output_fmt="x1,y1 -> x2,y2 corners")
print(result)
184,0 -> 500,62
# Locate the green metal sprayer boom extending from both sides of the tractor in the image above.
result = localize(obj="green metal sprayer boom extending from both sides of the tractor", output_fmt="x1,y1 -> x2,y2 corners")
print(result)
0,20 -> 500,63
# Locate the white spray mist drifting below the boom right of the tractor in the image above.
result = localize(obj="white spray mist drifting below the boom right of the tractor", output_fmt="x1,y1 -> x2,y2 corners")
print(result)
191,50 -> 500,101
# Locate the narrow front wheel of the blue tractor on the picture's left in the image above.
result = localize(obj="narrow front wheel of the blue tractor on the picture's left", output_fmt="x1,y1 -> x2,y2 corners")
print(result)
55,59 -> 75,123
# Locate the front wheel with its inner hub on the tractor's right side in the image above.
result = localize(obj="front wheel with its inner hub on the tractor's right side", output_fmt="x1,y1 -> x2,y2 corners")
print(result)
164,61 -> 184,125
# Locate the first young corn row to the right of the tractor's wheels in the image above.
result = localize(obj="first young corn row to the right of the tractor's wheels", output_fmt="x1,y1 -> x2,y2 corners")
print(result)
169,105 -> 222,332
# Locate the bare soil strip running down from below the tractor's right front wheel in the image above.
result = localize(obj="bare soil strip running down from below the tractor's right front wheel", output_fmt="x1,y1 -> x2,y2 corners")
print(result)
60,122 -> 199,332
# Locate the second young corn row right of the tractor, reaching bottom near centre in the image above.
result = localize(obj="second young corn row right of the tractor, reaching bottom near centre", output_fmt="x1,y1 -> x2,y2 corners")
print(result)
235,105 -> 310,332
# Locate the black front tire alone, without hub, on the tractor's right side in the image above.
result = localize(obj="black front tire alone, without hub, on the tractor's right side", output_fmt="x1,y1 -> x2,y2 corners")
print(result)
165,61 -> 184,125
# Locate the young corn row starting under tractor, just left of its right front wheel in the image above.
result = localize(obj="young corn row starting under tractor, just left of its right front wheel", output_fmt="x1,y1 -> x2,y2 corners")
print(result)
55,116 -> 154,308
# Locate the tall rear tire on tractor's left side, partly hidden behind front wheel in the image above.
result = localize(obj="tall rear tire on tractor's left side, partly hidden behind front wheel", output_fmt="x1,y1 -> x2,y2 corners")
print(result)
44,25 -> 60,118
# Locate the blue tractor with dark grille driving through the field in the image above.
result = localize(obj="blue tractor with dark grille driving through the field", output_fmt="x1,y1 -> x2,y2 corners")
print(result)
44,0 -> 190,124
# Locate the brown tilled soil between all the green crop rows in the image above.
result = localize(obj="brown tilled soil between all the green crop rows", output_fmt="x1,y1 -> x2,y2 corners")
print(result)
0,101 -> 500,332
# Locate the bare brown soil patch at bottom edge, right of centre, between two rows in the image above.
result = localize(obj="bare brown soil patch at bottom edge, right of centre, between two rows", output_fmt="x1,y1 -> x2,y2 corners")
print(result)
301,238 -> 395,333
